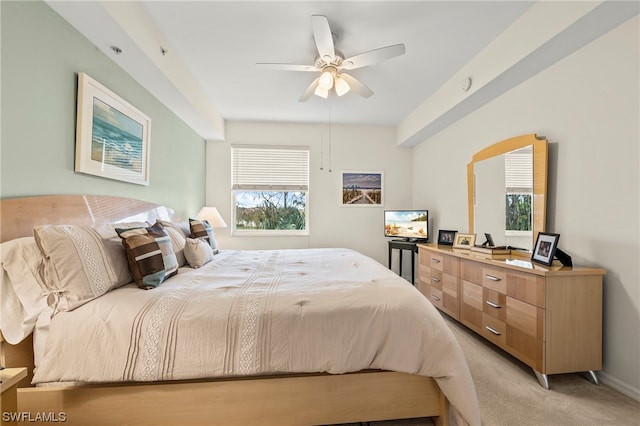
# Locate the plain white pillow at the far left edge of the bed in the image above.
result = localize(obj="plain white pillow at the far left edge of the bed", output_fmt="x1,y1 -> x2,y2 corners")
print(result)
0,237 -> 47,345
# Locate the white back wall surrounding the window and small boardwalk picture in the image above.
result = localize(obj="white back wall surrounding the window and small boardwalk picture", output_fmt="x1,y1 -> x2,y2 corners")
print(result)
206,122 -> 416,272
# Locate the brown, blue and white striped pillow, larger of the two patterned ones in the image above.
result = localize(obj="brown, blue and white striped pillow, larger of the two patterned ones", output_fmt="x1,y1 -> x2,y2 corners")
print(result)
116,223 -> 178,290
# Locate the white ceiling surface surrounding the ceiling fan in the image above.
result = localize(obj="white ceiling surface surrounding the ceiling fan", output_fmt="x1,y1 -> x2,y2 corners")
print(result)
47,1 -> 636,144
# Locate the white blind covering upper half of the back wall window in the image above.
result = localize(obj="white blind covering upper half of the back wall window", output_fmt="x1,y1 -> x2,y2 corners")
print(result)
231,145 -> 309,191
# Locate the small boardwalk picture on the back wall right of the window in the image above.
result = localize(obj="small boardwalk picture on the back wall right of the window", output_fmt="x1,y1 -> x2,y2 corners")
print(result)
340,172 -> 384,207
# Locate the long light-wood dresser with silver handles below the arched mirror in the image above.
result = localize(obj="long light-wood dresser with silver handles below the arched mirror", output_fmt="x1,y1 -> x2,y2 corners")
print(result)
417,244 -> 606,389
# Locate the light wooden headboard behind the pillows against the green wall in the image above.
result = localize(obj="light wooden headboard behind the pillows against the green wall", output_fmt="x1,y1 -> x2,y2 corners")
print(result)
0,195 -> 174,387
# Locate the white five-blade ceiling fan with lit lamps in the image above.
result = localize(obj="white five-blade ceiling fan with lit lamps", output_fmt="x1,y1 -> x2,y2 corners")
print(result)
256,15 -> 405,102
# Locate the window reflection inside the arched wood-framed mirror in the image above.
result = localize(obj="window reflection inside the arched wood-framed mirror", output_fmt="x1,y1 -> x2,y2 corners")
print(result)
504,147 -> 533,235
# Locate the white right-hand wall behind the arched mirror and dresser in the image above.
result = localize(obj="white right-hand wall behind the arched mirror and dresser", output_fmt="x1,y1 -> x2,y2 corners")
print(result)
413,17 -> 640,399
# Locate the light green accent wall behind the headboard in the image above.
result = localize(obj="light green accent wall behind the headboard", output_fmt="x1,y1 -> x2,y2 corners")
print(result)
0,1 -> 205,218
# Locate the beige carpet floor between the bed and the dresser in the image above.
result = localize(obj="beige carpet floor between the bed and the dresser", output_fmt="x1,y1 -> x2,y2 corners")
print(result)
362,318 -> 640,426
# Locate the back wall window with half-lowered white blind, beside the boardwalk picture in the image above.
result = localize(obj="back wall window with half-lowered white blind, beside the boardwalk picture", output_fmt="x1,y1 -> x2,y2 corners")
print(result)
231,145 -> 309,235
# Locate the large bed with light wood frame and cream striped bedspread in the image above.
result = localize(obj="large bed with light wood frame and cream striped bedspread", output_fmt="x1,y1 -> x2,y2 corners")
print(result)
0,195 -> 480,425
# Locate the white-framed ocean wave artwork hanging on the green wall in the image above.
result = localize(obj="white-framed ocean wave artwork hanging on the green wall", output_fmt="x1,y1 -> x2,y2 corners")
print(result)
75,73 -> 151,185
